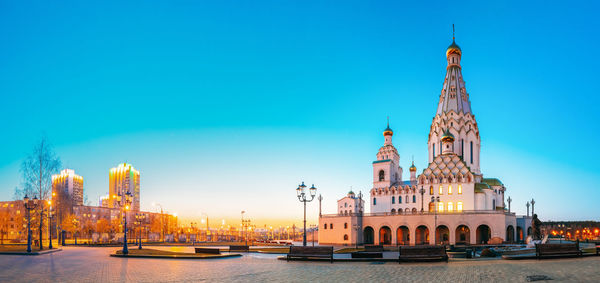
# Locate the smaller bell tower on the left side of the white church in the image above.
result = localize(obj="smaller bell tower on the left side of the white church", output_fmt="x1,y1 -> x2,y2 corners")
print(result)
373,122 -> 402,188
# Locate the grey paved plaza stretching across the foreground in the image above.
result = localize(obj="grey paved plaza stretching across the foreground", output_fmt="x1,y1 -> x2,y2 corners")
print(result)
0,247 -> 600,282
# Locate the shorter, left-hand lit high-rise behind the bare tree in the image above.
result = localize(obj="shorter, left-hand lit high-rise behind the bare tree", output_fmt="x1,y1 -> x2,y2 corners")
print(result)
52,169 -> 83,206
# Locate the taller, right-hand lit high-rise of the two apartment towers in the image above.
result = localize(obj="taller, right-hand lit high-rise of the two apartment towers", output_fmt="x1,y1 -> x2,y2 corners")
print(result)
108,163 -> 140,211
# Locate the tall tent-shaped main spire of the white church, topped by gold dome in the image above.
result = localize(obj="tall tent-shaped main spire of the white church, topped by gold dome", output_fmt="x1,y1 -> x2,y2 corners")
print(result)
427,26 -> 481,174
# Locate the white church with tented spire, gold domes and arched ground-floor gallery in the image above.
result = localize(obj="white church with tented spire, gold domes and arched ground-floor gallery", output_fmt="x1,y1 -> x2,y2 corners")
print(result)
319,34 -> 531,245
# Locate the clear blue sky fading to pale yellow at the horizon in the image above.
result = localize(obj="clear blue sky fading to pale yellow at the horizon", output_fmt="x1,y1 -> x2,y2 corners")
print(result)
0,0 -> 600,226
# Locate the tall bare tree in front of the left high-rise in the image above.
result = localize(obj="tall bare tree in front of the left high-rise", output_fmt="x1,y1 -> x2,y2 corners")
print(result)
21,137 -> 61,250
